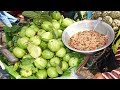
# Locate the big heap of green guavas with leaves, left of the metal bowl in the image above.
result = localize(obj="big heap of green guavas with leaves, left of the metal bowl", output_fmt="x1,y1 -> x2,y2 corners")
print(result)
0,11 -> 85,79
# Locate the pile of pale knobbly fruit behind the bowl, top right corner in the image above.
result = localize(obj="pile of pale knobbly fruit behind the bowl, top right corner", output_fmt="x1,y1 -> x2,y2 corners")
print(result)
91,11 -> 120,30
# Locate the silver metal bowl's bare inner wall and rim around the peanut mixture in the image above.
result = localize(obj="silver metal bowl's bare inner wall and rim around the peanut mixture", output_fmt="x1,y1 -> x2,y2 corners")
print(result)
62,20 -> 115,54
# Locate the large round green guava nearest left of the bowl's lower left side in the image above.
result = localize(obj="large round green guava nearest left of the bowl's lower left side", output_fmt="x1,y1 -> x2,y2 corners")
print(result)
48,39 -> 60,52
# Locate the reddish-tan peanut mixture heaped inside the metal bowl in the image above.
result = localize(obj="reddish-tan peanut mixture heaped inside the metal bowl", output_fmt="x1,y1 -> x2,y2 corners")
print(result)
68,30 -> 108,51
